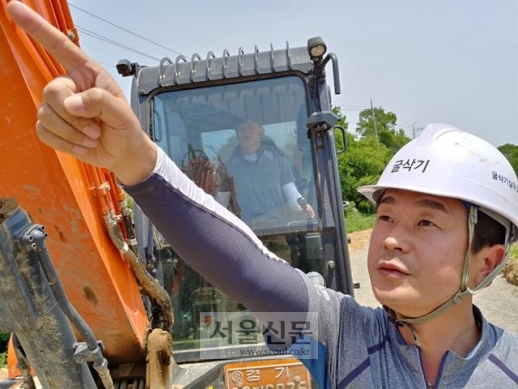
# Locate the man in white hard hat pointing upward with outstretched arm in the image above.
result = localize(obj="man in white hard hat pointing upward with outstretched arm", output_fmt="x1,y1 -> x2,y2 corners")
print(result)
8,1 -> 518,389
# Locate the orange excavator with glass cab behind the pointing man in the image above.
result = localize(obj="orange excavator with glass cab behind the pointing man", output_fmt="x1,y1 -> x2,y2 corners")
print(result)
0,0 -> 354,389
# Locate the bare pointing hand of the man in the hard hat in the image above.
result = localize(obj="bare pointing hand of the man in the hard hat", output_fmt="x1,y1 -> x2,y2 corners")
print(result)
7,1 -> 156,185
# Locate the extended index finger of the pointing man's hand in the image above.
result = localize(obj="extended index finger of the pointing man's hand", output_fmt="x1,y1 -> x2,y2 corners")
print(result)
7,1 -> 91,71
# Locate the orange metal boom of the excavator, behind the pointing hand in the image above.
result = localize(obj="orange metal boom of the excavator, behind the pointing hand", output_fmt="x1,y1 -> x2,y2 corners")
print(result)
0,0 -> 149,370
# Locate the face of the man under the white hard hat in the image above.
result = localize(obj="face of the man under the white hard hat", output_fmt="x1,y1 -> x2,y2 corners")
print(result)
368,189 -> 475,317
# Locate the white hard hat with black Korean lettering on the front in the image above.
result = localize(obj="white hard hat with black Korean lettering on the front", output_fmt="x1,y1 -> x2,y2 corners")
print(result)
358,123 -> 518,239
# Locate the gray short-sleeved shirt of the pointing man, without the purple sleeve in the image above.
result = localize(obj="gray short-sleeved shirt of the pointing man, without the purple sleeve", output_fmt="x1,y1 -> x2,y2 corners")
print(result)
303,272 -> 518,389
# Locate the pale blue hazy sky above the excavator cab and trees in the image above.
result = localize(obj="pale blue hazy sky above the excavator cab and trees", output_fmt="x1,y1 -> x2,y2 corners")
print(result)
69,0 -> 518,146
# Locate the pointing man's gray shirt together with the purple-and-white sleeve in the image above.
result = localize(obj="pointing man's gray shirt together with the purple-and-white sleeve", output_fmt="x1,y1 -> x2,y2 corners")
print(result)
126,150 -> 518,389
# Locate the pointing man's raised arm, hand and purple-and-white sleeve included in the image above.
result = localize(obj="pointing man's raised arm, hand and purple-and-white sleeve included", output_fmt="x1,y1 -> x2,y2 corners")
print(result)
8,1 -> 308,311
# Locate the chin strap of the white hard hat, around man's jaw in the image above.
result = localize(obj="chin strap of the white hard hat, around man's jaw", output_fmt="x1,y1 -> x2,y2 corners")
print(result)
385,204 -> 511,347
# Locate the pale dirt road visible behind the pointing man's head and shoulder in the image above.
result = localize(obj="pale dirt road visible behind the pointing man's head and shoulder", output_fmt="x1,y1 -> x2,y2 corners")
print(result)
349,230 -> 518,334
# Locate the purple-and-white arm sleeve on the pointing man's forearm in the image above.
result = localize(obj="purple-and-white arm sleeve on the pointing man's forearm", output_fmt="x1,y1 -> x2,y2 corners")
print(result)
125,150 -> 309,312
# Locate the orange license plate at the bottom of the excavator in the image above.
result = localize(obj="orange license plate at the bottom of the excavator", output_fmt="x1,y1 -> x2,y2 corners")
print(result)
224,358 -> 311,389
